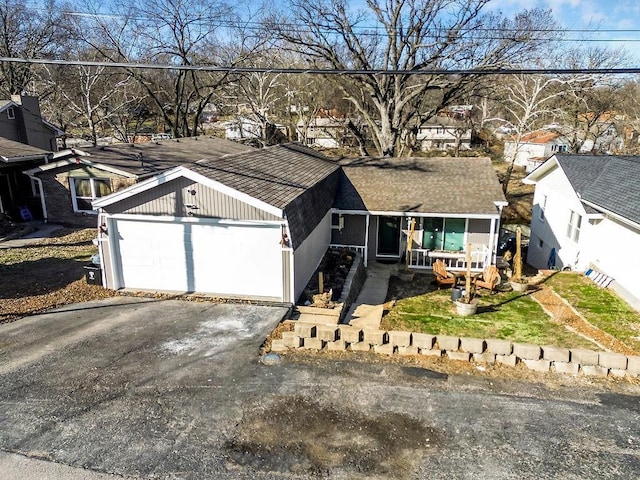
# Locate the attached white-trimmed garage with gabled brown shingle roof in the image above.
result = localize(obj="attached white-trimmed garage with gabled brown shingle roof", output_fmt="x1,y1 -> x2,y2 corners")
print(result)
93,145 -> 339,303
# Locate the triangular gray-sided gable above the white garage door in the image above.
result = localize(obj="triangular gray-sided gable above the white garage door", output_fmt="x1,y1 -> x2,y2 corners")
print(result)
105,177 -> 280,220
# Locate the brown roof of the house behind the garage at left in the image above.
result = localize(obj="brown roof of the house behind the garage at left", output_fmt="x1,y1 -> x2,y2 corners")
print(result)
80,137 -> 255,175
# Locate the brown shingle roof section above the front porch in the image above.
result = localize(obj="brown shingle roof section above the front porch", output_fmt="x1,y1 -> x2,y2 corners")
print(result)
334,158 -> 505,214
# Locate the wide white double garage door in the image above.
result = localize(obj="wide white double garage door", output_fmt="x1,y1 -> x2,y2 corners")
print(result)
115,219 -> 283,299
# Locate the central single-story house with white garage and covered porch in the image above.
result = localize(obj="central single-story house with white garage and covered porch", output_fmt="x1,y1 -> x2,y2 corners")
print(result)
93,144 -> 506,303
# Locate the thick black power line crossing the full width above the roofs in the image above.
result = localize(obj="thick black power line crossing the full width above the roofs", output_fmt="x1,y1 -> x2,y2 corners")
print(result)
0,57 -> 640,75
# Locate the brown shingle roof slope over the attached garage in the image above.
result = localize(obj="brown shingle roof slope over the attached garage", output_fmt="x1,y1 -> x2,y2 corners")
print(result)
186,144 -> 339,248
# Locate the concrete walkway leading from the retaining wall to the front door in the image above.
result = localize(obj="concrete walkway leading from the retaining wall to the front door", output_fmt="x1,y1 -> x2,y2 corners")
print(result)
345,262 -> 398,329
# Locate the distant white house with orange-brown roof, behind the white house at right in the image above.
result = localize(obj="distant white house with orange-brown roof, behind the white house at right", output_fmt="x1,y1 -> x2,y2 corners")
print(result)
504,130 -> 569,172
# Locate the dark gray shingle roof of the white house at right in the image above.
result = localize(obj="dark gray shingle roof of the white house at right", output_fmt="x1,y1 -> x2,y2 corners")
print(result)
555,155 -> 640,224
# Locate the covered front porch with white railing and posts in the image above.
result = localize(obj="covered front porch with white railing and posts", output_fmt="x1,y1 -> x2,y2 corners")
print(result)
331,210 -> 500,272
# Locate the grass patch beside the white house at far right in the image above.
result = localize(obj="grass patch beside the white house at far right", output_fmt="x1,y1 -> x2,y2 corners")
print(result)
546,272 -> 640,351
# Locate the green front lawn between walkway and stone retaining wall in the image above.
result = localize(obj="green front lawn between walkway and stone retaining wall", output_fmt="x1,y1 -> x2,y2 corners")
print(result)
382,275 -> 624,350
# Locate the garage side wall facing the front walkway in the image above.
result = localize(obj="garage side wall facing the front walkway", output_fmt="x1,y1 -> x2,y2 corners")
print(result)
293,211 -> 331,301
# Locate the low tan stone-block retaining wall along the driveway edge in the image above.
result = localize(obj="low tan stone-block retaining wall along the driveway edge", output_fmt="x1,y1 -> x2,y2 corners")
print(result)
271,322 -> 640,377
